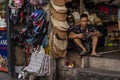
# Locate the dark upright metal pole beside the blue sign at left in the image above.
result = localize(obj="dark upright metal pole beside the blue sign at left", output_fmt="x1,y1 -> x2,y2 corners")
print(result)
5,0 -> 15,80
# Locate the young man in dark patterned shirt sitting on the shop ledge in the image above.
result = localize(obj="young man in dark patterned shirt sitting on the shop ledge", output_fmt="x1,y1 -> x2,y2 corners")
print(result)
68,14 -> 102,56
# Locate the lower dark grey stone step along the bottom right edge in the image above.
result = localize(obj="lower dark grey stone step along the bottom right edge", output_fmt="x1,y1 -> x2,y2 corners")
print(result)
57,68 -> 120,80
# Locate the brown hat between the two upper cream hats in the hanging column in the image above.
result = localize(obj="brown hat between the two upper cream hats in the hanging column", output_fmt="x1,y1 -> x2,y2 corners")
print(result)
51,8 -> 67,21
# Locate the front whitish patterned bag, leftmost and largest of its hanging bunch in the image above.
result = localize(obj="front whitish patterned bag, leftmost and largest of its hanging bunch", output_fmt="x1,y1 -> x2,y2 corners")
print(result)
27,47 -> 45,74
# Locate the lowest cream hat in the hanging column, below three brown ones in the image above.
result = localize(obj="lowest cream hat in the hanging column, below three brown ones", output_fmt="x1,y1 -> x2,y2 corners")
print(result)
53,35 -> 67,50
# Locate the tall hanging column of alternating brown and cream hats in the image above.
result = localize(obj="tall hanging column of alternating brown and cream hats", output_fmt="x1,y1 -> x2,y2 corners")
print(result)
49,0 -> 69,58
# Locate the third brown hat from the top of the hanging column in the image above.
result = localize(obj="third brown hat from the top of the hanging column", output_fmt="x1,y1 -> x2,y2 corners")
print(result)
53,26 -> 67,40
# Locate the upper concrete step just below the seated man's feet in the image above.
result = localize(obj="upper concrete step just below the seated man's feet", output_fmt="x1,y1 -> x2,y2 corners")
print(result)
82,51 -> 120,71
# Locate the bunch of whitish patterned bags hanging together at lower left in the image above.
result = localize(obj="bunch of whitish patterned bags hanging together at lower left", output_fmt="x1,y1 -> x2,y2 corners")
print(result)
27,46 -> 50,76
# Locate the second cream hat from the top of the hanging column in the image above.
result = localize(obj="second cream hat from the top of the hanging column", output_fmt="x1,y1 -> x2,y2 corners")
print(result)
51,16 -> 69,31
